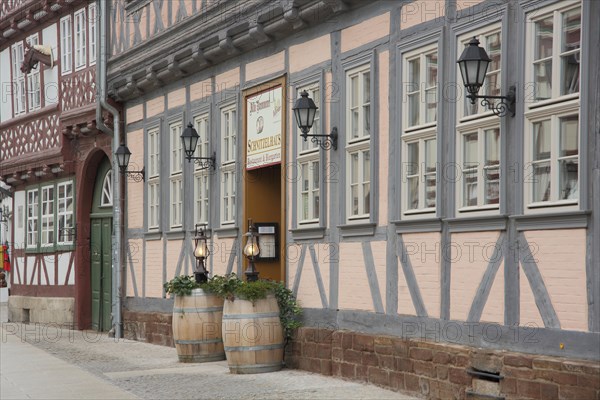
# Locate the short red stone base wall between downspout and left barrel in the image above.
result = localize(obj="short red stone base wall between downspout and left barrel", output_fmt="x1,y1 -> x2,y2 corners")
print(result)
123,310 -> 175,347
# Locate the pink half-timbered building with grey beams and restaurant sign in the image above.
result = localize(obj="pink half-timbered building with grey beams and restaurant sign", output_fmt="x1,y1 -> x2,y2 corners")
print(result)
107,0 -> 600,398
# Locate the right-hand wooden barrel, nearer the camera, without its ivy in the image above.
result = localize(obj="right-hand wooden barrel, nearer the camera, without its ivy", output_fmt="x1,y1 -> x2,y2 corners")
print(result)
223,295 -> 283,374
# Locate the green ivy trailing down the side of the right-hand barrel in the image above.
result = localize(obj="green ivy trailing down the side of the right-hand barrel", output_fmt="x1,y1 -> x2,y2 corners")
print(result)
200,273 -> 302,343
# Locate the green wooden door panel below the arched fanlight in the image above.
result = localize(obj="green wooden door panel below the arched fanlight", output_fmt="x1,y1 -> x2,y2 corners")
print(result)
90,218 -> 112,331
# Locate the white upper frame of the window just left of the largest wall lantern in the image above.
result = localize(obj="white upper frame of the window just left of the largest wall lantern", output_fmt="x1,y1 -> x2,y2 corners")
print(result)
402,43 -> 440,132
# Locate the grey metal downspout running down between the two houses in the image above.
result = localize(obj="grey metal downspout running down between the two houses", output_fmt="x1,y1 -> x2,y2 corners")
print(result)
96,0 -> 125,338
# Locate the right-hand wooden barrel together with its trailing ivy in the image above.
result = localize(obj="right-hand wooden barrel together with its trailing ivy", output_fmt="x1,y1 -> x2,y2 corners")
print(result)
201,274 -> 301,374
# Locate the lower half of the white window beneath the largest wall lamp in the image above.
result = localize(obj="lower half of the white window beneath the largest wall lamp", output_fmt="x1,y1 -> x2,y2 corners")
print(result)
459,127 -> 500,210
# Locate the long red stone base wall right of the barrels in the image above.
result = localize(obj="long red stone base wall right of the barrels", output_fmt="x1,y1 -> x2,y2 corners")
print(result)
286,328 -> 600,400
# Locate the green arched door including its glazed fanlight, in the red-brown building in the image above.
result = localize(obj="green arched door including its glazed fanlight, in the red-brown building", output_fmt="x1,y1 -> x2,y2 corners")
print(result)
90,158 -> 113,331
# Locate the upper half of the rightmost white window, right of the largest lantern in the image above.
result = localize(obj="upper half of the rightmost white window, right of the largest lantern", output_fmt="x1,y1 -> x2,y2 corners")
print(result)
528,2 -> 581,102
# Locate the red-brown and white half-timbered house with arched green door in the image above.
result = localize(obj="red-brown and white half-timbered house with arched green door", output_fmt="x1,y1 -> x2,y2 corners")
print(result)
0,0 -> 117,329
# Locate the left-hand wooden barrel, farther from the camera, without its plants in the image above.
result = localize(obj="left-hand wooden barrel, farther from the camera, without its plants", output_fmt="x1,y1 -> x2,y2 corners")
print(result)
173,289 -> 225,362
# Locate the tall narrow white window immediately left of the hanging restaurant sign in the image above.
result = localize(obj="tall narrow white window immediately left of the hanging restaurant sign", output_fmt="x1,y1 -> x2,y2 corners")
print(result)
221,106 -> 237,225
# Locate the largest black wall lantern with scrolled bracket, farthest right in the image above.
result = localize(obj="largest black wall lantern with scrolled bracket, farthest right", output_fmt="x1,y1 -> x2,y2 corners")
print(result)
457,37 -> 517,117
